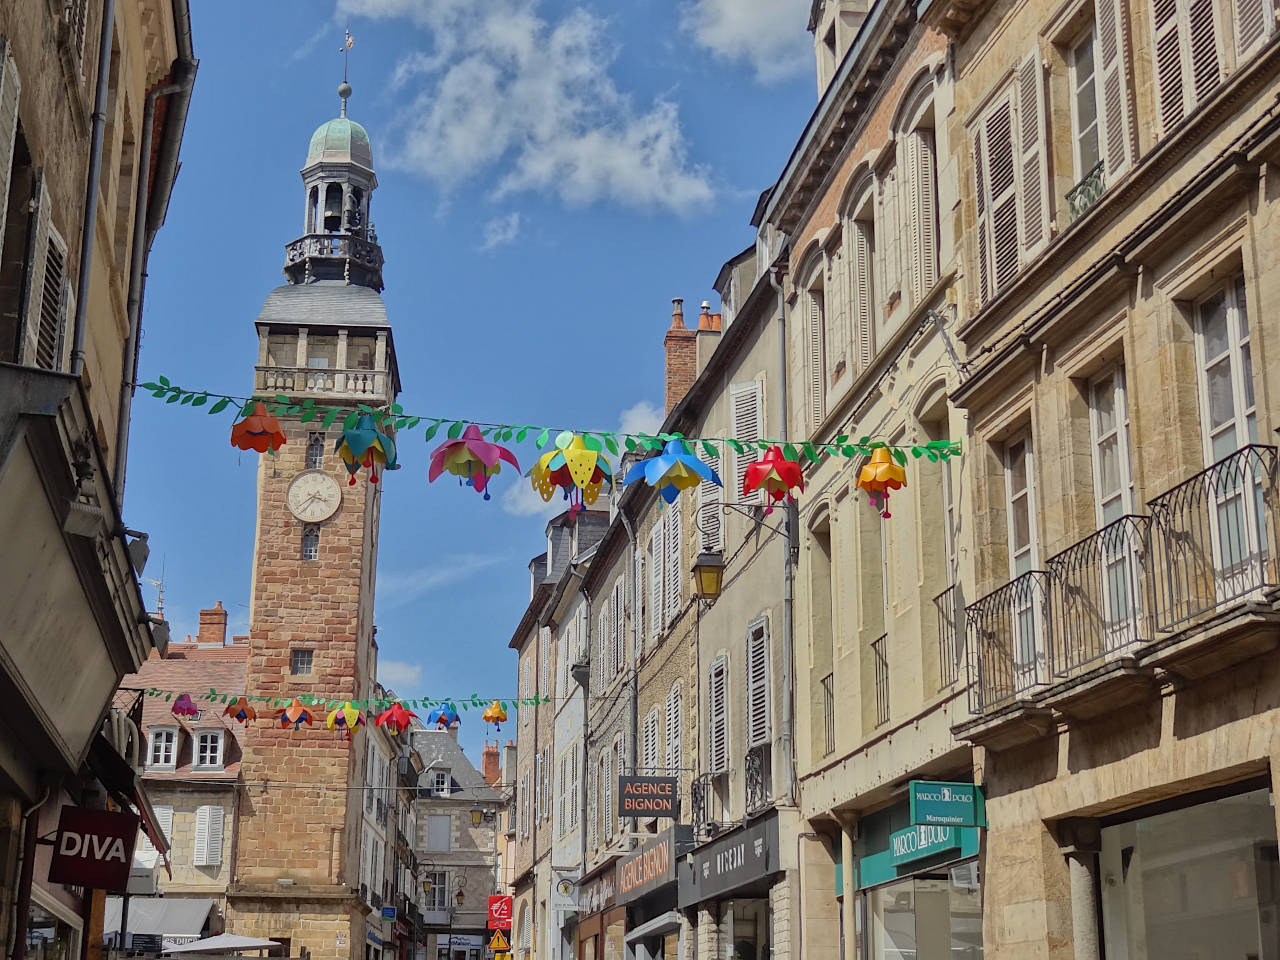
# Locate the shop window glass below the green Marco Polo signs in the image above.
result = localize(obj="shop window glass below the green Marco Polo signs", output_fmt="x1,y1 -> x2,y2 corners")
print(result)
867,860 -> 982,960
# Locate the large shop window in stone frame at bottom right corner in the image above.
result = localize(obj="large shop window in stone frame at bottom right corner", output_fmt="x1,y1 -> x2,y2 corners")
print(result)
1098,788 -> 1280,960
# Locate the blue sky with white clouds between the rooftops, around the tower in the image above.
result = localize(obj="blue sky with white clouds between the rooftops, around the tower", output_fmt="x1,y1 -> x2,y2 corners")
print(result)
125,0 -> 815,750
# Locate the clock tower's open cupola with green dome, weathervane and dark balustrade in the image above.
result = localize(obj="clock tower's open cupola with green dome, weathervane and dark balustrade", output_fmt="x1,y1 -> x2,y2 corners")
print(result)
284,81 -> 383,292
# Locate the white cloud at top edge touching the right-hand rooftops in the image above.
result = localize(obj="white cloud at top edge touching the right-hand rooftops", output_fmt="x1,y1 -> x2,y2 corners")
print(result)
680,0 -> 813,83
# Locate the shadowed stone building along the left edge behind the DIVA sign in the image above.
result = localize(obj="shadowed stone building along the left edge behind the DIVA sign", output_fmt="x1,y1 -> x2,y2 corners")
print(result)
0,0 -> 196,952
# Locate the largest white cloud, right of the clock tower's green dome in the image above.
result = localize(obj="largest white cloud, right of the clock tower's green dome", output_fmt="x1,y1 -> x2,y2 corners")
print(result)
338,0 -> 712,214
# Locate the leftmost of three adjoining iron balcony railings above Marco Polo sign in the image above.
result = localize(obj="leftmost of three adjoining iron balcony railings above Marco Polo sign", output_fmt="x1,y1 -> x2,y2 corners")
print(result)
965,570 -> 1050,713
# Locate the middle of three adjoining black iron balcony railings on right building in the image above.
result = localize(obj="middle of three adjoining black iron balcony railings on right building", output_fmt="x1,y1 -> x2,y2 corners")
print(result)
1047,515 -> 1151,677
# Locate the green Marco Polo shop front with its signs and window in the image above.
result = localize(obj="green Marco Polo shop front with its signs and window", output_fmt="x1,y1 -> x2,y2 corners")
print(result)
836,781 -> 984,960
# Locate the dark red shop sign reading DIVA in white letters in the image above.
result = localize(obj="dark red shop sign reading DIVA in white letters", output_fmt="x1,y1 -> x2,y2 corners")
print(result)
49,806 -> 138,893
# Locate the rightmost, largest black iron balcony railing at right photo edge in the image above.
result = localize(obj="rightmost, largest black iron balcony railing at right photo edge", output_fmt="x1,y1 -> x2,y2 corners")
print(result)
1147,444 -> 1280,632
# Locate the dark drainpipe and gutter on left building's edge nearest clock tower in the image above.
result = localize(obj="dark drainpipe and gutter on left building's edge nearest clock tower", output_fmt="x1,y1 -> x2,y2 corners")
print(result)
113,0 -> 200,513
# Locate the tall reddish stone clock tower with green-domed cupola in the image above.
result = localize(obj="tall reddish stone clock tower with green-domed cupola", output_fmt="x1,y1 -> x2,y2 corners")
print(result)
227,83 -> 399,960
